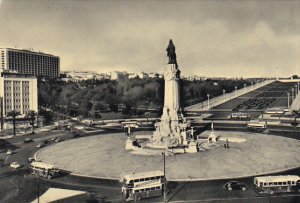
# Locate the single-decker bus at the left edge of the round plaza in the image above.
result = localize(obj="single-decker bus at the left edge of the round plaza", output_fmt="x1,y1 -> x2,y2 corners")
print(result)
29,161 -> 59,179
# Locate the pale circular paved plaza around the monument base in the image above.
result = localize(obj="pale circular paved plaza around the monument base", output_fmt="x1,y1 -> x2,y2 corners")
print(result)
37,131 -> 300,181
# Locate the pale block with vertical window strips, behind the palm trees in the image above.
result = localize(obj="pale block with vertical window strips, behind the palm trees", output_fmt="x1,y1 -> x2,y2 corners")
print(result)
0,71 -> 38,117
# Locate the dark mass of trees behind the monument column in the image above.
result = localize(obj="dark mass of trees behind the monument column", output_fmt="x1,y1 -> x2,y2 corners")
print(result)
38,78 -> 251,116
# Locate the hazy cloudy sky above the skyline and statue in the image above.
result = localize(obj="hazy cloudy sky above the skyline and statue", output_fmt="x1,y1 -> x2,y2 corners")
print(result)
0,0 -> 300,77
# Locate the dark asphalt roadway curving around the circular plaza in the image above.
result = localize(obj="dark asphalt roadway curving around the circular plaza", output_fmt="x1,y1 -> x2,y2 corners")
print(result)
0,126 -> 300,203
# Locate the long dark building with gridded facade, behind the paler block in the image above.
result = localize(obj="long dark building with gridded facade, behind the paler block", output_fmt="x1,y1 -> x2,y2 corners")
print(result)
0,48 -> 60,78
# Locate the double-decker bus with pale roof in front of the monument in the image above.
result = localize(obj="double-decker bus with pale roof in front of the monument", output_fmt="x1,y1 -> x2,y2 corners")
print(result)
120,171 -> 166,201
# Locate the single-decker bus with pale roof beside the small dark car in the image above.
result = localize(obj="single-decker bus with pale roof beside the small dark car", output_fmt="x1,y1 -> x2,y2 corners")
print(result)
254,175 -> 300,195
